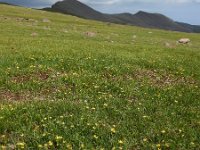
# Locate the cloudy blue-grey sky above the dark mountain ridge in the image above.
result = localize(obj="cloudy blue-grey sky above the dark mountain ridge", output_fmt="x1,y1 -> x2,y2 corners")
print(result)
0,0 -> 200,25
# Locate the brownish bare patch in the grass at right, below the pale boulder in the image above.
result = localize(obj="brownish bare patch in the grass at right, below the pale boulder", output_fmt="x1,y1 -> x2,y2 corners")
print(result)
133,69 -> 197,87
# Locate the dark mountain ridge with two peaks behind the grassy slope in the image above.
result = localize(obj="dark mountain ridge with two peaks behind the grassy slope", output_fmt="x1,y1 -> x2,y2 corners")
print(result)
44,0 -> 200,33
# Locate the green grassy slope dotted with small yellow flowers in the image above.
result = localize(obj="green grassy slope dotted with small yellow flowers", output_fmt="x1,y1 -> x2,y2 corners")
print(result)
0,5 -> 200,150
